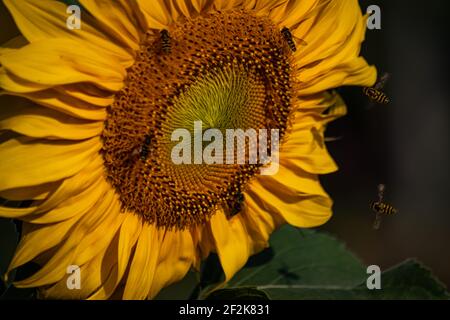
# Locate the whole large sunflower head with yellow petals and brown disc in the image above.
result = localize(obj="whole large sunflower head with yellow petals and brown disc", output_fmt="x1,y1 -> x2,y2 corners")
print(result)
0,0 -> 376,299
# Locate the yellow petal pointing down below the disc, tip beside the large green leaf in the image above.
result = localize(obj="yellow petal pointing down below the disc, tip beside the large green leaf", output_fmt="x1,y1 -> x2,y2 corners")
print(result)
210,210 -> 251,281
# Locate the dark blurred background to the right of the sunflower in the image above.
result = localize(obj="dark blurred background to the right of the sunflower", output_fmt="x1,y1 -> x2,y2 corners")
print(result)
0,0 -> 450,287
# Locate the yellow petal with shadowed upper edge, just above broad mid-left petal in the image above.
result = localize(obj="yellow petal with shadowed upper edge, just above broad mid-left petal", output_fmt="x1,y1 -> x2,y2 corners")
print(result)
0,98 -> 103,140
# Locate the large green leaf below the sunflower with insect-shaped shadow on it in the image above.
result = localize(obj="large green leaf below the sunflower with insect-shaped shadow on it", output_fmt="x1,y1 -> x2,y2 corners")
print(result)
228,226 -> 366,298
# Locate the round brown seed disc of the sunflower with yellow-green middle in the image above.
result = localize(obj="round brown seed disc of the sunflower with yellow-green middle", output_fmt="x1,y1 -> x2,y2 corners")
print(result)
102,12 -> 294,229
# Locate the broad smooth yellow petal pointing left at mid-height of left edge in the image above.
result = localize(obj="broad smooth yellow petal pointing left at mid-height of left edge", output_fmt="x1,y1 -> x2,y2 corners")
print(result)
0,137 -> 101,190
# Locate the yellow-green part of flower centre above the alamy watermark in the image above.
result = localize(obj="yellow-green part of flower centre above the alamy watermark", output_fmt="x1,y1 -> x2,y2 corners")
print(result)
168,66 -> 266,132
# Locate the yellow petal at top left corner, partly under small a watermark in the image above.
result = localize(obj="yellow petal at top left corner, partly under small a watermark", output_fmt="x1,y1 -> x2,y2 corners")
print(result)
4,0 -> 133,67
